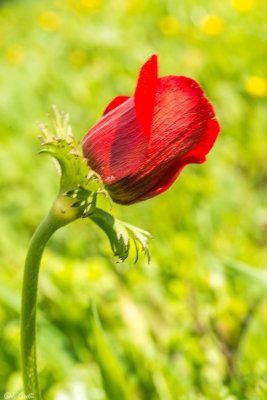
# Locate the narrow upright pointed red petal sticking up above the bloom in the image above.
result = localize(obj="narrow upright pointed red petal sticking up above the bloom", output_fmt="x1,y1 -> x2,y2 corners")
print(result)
134,54 -> 158,141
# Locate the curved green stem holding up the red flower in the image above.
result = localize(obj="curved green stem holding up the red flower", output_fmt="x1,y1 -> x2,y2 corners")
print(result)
21,196 -> 80,400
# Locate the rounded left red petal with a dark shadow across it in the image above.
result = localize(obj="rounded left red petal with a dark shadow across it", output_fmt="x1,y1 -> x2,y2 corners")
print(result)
82,97 -> 147,184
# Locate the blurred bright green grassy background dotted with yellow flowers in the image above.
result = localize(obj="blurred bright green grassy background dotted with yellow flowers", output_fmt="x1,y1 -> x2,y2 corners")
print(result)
0,0 -> 267,400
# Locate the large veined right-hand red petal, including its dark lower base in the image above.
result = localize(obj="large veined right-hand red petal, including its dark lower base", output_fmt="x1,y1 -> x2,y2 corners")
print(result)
105,76 -> 220,204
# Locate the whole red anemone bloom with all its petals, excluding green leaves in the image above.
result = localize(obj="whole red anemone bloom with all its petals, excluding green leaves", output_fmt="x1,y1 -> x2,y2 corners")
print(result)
82,55 -> 220,204
